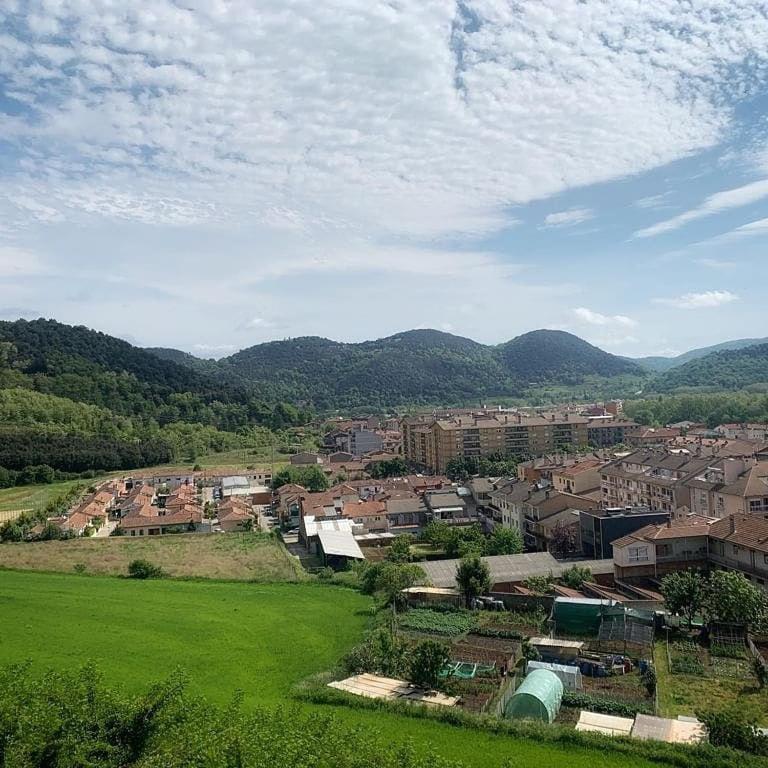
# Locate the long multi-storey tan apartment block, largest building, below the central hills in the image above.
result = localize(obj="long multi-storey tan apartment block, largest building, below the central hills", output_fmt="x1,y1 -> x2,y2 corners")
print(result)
401,412 -> 639,472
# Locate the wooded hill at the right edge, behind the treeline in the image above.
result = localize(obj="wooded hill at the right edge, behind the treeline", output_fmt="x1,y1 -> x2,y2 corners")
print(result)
651,344 -> 768,392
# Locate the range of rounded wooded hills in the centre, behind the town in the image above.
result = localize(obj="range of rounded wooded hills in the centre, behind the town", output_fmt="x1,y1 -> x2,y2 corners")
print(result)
212,329 -> 643,408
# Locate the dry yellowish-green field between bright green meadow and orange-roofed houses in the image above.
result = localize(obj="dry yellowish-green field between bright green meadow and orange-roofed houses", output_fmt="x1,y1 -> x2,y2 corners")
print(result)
0,533 -> 304,581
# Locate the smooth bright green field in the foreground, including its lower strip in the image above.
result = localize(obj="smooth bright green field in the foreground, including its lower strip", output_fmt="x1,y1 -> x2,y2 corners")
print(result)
0,571 -> 651,768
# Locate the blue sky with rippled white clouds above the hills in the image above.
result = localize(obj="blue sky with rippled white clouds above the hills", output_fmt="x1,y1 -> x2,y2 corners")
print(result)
0,0 -> 768,357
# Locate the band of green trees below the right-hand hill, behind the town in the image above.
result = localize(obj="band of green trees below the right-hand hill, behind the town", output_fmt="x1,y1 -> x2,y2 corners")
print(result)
624,392 -> 768,428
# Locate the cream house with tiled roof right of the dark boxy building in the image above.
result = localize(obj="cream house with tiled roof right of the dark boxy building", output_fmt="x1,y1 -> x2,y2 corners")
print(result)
612,516 -> 714,580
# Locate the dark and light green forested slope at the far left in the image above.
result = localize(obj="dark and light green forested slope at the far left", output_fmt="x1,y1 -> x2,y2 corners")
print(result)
0,320 -> 311,485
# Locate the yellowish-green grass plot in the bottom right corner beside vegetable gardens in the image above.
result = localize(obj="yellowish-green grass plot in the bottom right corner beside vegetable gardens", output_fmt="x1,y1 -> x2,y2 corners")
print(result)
654,641 -> 768,726
